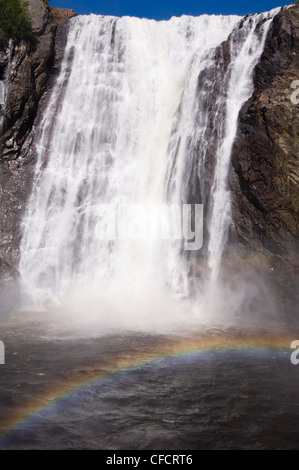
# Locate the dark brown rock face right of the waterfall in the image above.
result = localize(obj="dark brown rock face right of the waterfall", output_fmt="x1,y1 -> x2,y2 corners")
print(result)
230,5 -> 299,316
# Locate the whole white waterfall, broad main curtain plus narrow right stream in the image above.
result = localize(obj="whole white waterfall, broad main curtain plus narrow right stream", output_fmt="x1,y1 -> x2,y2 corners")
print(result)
20,12 -> 282,326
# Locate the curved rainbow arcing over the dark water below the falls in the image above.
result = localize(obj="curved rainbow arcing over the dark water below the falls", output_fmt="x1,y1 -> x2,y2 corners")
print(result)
0,333 -> 295,443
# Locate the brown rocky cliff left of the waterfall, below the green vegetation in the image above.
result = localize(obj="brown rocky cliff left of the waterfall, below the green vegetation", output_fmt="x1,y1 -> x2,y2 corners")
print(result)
0,0 -> 75,310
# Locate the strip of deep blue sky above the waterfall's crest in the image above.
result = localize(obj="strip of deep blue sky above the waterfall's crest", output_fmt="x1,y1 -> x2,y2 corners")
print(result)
50,0 -> 286,20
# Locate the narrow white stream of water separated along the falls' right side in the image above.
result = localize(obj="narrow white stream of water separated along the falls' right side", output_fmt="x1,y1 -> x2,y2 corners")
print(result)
208,14 -> 271,282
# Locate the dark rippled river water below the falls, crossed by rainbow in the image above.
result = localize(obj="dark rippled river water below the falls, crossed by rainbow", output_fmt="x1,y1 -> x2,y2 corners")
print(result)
0,315 -> 299,450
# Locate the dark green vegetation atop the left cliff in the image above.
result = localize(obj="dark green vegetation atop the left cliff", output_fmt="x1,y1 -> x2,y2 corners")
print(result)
0,0 -> 36,48
